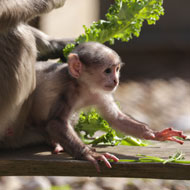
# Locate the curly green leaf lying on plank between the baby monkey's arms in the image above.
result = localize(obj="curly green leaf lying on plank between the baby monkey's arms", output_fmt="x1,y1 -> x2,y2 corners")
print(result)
75,109 -> 148,146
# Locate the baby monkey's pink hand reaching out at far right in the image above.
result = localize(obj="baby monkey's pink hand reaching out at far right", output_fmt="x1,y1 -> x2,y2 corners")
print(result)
154,128 -> 187,144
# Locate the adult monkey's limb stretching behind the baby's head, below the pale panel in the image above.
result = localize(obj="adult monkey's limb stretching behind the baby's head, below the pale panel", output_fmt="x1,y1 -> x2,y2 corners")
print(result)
31,27 -> 72,62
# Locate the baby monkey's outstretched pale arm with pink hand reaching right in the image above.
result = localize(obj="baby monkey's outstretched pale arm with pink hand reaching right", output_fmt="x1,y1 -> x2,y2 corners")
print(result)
99,95 -> 186,144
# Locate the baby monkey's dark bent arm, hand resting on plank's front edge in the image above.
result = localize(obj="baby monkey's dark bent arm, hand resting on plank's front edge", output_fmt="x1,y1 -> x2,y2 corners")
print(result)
47,120 -> 118,172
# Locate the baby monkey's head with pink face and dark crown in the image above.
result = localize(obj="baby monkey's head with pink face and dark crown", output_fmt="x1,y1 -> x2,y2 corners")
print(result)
68,42 -> 121,92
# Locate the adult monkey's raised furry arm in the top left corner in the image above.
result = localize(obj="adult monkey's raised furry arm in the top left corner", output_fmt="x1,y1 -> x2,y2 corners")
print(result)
0,0 -> 65,32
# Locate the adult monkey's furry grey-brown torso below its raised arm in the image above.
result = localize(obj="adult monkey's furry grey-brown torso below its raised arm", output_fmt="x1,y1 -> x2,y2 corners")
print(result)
0,24 -> 37,138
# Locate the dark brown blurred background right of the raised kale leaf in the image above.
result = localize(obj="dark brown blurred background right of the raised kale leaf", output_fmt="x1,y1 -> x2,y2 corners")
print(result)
100,0 -> 190,81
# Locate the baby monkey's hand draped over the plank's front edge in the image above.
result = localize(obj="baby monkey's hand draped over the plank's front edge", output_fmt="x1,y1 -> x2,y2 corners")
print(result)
84,149 -> 119,172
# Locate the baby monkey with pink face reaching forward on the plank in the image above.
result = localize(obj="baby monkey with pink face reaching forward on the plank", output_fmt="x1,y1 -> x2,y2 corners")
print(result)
30,42 -> 185,171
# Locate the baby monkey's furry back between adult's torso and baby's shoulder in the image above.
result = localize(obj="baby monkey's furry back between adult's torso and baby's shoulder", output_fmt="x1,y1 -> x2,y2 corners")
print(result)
30,62 -> 68,122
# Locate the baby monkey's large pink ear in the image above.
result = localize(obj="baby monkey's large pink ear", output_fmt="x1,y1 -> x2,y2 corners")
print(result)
68,53 -> 82,78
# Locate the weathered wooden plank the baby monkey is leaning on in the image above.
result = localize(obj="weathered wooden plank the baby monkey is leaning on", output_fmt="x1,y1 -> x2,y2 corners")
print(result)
0,142 -> 190,180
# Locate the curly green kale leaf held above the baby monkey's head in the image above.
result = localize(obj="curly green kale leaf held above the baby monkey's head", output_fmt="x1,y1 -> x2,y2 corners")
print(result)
63,0 -> 164,57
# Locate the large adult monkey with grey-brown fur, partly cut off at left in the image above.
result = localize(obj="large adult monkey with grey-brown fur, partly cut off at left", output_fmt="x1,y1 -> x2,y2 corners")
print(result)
0,0 -> 65,141
